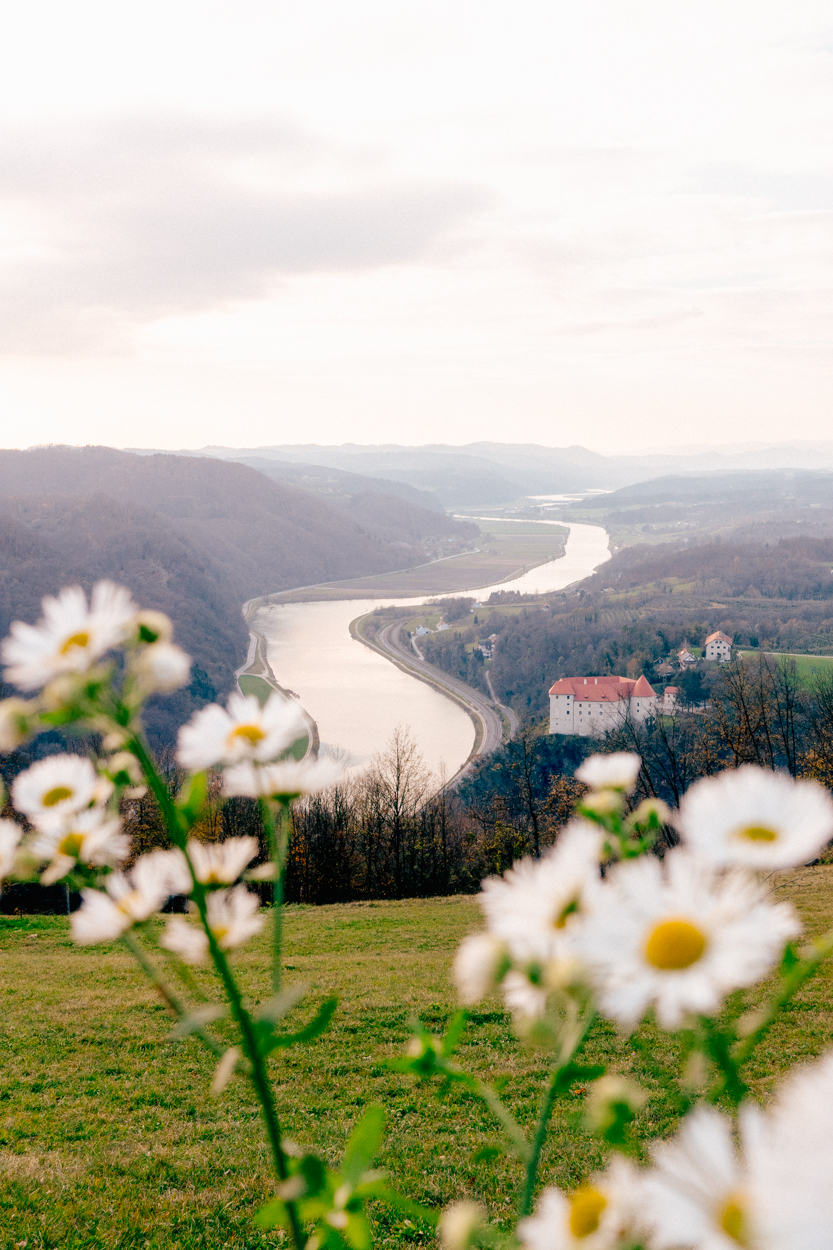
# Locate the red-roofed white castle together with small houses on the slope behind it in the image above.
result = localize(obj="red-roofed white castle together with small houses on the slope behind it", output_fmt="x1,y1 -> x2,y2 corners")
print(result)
549,630 -> 732,736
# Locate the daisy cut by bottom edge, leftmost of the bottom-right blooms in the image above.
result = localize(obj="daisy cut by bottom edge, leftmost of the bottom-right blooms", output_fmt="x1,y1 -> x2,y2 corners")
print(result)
518,1158 -> 642,1250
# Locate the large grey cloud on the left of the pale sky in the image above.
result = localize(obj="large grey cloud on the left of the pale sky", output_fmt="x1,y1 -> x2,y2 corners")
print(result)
0,116 -> 494,354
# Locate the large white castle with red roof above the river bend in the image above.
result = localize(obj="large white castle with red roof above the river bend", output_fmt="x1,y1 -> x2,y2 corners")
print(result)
549,676 -> 658,736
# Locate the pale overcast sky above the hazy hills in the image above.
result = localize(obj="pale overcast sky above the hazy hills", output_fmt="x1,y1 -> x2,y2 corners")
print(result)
0,0 -> 833,453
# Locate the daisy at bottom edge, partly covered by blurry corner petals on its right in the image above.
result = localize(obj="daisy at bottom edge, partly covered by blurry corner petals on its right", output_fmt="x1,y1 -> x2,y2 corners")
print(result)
642,1106 -> 759,1250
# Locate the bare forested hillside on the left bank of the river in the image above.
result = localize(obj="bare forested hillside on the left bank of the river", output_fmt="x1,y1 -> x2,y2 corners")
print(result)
0,448 -> 465,741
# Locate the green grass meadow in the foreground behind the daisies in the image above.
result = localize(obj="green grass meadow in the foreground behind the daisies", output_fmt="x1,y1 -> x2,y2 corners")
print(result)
0,868 -> 833,1250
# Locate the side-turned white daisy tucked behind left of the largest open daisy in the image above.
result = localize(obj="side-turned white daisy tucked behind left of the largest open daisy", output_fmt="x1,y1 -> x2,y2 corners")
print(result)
480,820 -> 602,961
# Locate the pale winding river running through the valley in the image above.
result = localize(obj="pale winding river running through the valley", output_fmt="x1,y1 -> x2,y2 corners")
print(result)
253,523 -> 610,776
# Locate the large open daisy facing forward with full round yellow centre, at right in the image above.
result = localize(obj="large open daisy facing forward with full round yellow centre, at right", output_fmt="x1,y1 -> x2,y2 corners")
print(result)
575,850 -> 800,1029
